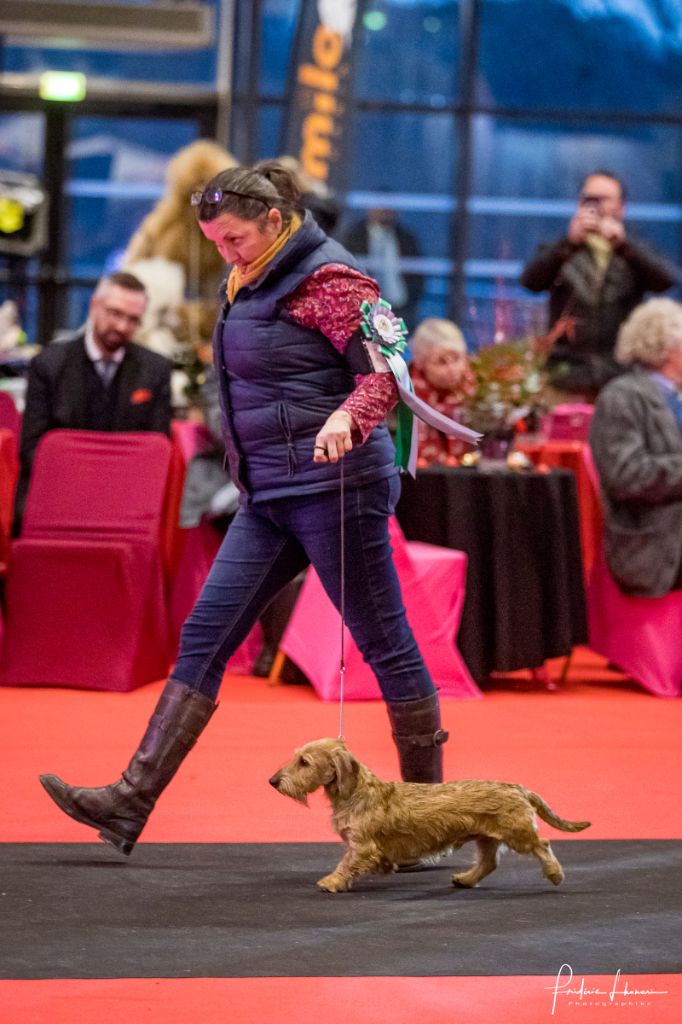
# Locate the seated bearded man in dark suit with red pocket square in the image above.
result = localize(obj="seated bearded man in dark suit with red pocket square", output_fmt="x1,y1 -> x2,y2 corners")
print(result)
14,272 -> 172,532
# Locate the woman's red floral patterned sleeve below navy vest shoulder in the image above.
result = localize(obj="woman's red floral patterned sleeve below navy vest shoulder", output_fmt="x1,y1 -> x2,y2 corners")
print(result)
287,263 -> 398,440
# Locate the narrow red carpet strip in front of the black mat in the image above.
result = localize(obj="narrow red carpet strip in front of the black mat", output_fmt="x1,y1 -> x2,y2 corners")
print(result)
0,974 -> 682,1024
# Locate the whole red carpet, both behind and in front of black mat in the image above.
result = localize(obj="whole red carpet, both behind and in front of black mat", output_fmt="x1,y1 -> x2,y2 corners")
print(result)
0,652 -> 682,1024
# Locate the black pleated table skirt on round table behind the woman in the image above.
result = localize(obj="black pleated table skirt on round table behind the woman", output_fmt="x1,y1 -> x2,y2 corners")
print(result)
397,467 -> 587,682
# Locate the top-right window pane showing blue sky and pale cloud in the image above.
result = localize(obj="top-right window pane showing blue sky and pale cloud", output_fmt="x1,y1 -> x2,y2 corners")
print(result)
476,0 -> 682,117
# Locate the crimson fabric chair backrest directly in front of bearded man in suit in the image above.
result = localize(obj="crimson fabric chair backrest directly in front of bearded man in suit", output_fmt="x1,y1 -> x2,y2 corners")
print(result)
22,430 -> 172,540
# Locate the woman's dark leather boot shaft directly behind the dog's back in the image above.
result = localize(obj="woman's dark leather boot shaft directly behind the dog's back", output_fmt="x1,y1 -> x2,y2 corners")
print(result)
386,693 -> 447,782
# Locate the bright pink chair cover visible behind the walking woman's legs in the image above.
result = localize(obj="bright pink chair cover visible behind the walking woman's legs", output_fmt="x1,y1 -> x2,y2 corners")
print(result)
281,519 -> 482,700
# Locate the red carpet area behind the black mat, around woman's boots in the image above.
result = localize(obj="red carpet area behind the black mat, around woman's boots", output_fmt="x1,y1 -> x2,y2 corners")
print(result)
0,654 -> 682,843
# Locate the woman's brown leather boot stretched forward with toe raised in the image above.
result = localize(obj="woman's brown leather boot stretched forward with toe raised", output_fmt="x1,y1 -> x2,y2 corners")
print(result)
40,680 -> 217,856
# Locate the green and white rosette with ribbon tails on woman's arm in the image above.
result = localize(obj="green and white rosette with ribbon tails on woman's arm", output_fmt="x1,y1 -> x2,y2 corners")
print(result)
360,299 -> 482,476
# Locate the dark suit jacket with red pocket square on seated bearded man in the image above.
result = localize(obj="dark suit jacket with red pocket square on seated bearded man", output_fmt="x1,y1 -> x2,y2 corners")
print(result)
14,331 -> 172,529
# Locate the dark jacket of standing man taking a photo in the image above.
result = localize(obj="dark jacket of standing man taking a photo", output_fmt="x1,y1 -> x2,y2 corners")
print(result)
521,239 -> 675,393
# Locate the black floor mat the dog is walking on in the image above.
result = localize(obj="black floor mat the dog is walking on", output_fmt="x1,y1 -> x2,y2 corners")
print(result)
0,840 -> 682,978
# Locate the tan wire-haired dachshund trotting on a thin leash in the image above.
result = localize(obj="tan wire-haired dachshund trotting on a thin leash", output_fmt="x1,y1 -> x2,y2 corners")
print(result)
269,739 -> 590,893
